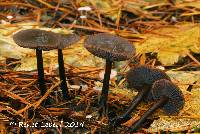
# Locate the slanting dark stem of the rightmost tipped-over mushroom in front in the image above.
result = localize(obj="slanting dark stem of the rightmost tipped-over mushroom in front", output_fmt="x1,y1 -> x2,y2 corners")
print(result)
131,96 -> 168,132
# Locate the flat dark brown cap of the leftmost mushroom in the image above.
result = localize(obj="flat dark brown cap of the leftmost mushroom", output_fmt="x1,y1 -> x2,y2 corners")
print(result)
13,29 -> 60,50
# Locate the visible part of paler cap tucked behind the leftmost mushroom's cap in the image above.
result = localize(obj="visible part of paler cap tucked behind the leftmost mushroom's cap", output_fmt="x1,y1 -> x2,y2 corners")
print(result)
58,34 -> 80,49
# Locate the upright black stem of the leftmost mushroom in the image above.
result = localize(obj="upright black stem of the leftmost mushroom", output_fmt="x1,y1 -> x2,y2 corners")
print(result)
36,48 -> 47,96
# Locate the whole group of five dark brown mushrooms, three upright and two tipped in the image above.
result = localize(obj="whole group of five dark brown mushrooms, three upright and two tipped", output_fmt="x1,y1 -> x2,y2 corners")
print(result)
13,29 -> 184,131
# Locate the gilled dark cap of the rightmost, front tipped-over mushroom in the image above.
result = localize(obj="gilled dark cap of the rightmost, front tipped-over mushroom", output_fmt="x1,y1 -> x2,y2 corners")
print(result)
151,79 -> 185,115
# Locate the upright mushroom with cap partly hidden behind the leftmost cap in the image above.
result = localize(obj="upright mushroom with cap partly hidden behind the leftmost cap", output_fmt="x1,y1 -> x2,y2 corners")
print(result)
58,34 -> 80,99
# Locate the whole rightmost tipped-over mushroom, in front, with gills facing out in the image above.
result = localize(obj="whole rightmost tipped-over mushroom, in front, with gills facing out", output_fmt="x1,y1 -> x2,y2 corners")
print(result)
131,79 -> 185,131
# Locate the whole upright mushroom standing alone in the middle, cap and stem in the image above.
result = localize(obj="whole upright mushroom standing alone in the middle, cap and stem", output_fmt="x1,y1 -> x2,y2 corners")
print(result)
84,33 -> 135,115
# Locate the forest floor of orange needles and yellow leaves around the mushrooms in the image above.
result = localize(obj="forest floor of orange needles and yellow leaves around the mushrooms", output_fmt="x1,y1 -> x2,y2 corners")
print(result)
0,0 -> 200,134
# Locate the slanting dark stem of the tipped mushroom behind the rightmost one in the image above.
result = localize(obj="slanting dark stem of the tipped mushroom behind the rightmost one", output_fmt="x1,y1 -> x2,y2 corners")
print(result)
113,86 -> 149,126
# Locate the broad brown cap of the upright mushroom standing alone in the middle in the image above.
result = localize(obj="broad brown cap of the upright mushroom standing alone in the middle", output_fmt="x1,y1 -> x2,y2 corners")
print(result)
84,33 -> 135,61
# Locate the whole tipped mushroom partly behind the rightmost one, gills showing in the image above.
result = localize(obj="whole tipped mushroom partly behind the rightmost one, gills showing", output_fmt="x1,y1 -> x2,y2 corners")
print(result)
110,65 -> 170,126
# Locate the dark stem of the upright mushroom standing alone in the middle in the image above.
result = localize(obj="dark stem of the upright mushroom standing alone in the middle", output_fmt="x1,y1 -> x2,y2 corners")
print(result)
99,59 -> 112,115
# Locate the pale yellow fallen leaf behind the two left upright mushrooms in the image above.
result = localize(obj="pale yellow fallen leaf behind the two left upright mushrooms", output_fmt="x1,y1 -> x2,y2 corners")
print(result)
0,23 -> 105,71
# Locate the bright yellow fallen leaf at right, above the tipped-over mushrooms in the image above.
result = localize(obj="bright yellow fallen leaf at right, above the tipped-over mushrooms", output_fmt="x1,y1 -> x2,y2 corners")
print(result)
136,23 -> 200,65
